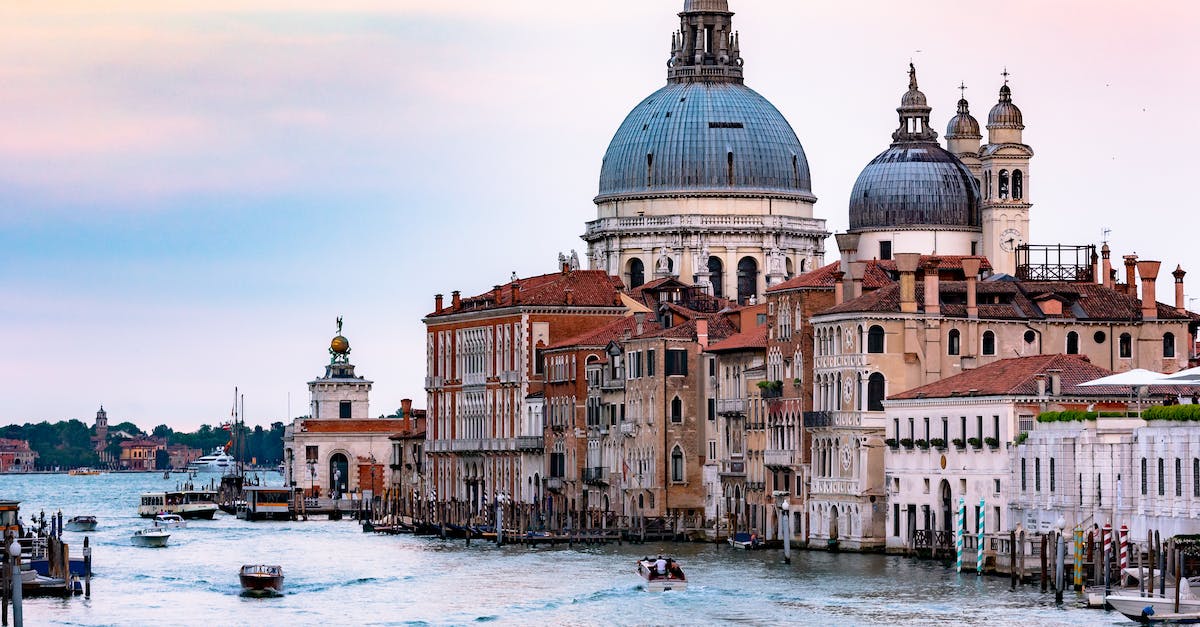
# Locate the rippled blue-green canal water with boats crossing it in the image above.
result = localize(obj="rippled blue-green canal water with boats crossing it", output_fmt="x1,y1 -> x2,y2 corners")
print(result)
0,473 -> 1133,627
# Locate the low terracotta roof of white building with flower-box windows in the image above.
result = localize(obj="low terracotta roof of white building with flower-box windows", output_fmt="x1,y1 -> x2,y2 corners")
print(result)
890,354 -> 1129,400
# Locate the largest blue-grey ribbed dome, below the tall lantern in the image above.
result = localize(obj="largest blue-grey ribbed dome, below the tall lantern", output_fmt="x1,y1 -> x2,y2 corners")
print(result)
596,80 -> 816,203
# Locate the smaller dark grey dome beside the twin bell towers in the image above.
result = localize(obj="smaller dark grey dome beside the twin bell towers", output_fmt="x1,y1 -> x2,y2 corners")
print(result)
850,142 -> 980,231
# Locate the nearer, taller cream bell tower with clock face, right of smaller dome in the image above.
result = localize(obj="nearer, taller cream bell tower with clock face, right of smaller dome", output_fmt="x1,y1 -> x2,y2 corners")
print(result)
979,70 -> 1033,274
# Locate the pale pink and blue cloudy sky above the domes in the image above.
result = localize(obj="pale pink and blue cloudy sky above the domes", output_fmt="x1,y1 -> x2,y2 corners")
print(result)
0,0 -> 1200,430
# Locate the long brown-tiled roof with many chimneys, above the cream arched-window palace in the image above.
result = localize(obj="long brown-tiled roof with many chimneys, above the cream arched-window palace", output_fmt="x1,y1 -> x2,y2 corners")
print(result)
820,277 -> 1194,322
